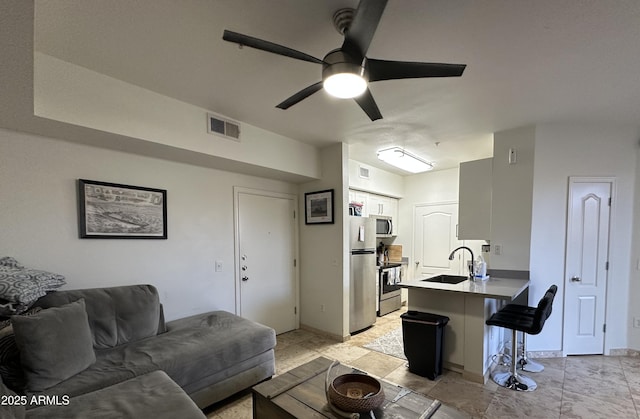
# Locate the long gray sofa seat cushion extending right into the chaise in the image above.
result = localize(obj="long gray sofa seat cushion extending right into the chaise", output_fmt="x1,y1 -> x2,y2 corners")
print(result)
24,311 -> 276,397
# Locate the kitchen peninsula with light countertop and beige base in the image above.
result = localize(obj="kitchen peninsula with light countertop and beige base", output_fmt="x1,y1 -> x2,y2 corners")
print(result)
401,276 -> 529,384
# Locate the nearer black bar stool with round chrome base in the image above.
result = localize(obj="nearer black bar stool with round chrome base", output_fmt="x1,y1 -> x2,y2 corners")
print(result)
486,285 -> 558,391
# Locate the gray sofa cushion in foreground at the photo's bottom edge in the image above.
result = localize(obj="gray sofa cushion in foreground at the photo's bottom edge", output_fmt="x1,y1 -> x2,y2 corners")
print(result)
27,371 -> 206,419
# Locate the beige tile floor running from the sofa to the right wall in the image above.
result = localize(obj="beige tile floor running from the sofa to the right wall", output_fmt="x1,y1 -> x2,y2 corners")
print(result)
205,311 -> 640,419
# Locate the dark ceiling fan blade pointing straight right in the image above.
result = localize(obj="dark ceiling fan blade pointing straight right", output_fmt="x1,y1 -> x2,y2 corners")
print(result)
367,59 -> 467,82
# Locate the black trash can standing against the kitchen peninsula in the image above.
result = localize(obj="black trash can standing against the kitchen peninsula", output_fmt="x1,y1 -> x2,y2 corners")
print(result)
400,310 -> 449,380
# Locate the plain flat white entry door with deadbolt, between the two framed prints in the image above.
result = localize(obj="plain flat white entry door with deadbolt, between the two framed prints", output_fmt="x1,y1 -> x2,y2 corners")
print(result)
235,188 -> 298,334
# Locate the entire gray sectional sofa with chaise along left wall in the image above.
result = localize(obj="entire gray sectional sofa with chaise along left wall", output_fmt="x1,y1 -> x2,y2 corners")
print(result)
0,285 -> 276,418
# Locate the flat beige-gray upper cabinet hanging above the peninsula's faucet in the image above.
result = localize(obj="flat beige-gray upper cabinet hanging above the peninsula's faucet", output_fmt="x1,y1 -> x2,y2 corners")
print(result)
458,158 -> 493,240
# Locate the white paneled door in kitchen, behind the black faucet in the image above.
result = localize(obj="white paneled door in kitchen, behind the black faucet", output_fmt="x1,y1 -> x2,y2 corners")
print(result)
413,203 -> 462,279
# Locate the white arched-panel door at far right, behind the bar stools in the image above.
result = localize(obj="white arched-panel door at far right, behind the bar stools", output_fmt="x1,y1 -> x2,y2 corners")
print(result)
564,178 -> 613,355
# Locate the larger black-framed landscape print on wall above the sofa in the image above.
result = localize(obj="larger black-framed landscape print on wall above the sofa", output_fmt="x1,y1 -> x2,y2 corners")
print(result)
78,179 -> 167,239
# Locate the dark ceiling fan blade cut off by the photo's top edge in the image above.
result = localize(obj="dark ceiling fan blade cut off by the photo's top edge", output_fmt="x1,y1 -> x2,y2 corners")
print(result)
342,0 -> 387,61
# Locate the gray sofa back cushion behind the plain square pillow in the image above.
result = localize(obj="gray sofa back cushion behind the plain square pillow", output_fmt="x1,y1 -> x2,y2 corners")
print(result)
35,285 -> 164,349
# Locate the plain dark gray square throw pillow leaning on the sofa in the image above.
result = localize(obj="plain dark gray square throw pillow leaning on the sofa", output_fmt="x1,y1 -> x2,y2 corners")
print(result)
11,299 -> 96,391
